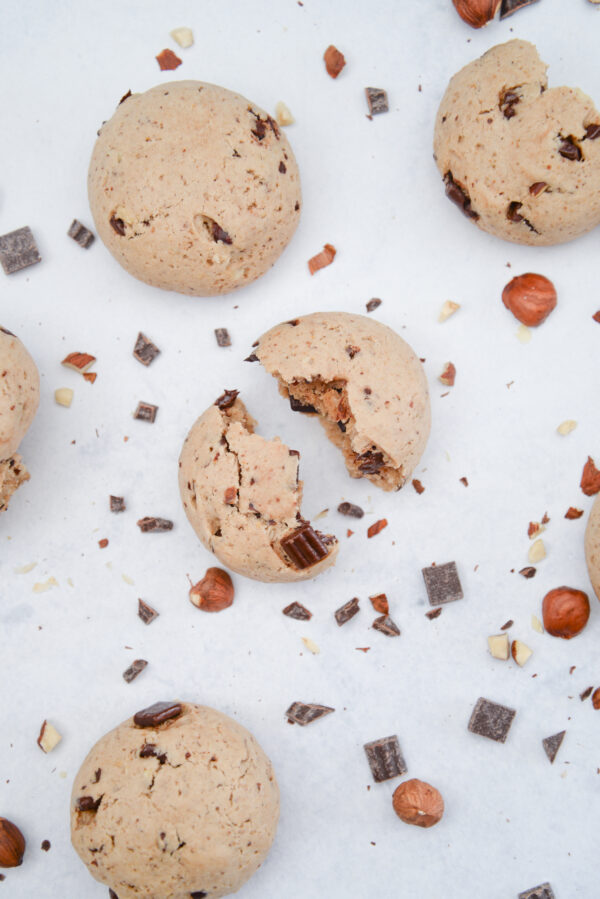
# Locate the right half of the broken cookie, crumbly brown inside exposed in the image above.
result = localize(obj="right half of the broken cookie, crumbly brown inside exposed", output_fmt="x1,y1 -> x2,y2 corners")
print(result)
253,312 -> 430,490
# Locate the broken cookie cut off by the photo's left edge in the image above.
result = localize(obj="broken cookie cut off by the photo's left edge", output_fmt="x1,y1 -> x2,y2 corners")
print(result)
0,327 -> 40,512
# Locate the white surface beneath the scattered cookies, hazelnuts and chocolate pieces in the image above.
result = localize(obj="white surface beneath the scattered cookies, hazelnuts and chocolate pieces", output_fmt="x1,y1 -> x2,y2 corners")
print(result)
0,0 -> 600,899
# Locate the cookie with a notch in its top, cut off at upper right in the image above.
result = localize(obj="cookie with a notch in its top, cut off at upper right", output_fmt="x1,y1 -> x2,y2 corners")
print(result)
434,40 -> 600,246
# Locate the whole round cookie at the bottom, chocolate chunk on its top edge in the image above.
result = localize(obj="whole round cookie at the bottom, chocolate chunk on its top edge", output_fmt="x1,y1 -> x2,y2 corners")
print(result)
71,703 -> 279,899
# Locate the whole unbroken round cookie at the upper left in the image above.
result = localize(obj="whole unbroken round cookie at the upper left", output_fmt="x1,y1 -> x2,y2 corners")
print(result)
88,81 -> 301,296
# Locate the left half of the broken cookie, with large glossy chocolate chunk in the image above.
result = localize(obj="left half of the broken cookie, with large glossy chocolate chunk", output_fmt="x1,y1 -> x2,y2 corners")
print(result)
179,390 -> 338,582
